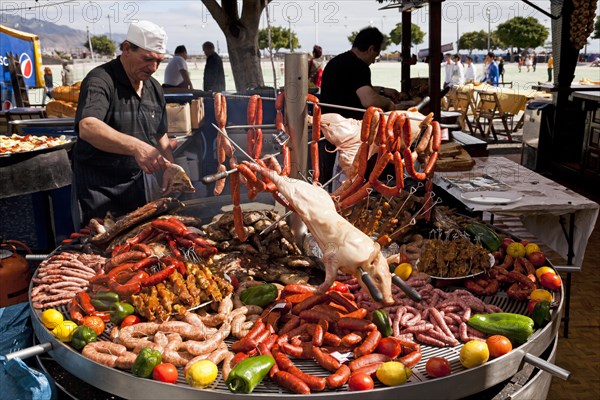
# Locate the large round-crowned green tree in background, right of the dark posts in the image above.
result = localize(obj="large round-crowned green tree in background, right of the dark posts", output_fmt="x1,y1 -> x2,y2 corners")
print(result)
495,17 -> 549,48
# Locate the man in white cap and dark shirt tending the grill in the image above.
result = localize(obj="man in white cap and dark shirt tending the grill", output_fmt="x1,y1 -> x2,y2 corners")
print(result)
72,21 -> 178,225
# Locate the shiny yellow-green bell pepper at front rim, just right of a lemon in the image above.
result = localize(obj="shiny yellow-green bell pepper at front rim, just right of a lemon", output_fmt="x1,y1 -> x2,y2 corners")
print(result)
225,355 -> 275,393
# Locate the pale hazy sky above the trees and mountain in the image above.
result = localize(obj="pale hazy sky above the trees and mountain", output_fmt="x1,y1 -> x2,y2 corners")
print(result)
0,0 -> 600,54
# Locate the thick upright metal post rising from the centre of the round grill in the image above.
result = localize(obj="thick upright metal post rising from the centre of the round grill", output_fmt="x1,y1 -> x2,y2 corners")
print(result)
285,52 -> 308,245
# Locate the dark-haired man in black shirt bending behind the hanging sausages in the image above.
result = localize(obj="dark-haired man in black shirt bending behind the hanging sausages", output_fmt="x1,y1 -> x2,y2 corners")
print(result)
319,28 -> 400,183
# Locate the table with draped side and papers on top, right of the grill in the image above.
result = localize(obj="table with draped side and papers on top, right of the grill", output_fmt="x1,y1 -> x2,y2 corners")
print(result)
433,157 -> 600,337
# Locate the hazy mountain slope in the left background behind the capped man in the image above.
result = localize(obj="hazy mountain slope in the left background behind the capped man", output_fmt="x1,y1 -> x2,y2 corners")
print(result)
0,13 -> 125,54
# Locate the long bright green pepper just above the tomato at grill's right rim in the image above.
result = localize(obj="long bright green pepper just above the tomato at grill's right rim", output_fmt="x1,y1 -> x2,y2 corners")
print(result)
467,313 -> 533,345
